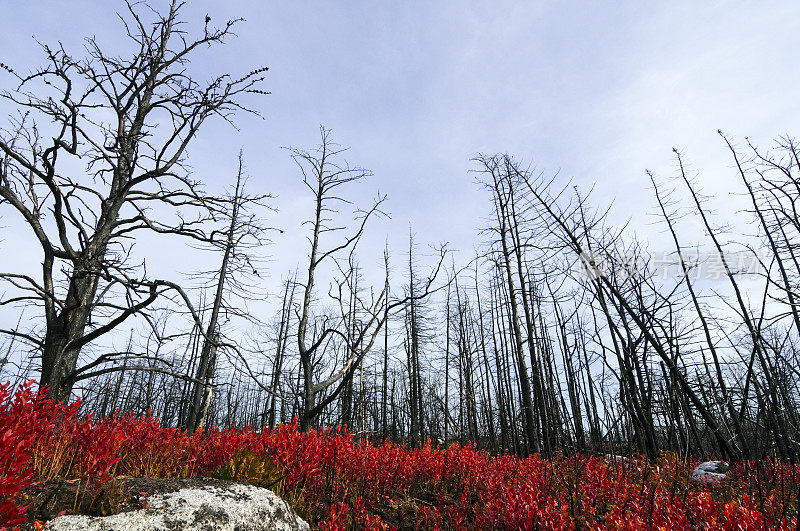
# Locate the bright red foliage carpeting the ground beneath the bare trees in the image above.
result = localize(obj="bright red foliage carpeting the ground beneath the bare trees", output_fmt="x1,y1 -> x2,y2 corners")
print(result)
0,384 -> 800,530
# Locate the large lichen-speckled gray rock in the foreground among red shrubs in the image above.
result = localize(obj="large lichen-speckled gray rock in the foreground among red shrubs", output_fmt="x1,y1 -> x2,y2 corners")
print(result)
45,484 -> 309,531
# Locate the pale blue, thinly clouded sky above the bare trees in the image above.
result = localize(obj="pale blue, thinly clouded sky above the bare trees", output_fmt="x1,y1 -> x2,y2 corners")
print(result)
0,0 -> 800,356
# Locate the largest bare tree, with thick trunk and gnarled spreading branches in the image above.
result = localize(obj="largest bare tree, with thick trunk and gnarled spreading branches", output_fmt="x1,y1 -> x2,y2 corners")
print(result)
0,0 -> 266,400
